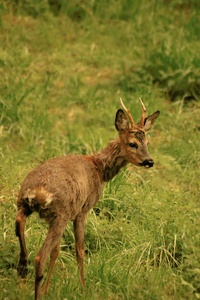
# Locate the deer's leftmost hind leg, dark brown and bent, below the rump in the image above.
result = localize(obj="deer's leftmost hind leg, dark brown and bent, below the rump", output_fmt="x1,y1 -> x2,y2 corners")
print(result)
15,208 -> 28,278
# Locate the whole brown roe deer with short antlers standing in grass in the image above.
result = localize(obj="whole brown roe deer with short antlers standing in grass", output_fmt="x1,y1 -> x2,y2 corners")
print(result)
16,99 -> 159,300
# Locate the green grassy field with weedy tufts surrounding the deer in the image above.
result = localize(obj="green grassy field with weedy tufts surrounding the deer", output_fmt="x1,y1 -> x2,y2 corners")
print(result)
0,0 -> 200,300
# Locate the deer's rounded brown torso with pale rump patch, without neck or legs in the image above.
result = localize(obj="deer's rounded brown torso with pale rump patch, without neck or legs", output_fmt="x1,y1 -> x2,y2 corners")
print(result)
18,155 -> 103,221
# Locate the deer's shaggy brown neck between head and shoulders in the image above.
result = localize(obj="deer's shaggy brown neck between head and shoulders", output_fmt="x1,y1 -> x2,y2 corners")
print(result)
93,139 -> 127,181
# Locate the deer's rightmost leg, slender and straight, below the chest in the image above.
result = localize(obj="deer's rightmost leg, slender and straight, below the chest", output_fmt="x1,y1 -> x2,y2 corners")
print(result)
74,212 -> 86,285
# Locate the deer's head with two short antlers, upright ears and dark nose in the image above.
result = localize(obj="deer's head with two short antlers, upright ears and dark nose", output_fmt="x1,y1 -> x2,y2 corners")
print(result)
115,99 -> 160,168
